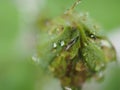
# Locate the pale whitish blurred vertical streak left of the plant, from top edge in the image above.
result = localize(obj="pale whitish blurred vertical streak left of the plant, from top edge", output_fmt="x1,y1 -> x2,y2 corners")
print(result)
13,0 -> 45,56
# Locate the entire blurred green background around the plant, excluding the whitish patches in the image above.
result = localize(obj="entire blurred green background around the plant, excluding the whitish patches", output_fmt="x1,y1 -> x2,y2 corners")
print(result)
0,0 -> 120,90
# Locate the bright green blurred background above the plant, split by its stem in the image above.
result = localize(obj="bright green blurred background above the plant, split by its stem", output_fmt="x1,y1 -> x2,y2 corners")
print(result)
46,0 -> 120,30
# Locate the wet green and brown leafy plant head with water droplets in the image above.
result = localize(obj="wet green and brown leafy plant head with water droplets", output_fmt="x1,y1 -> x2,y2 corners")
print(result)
36,0 -> 116,90
